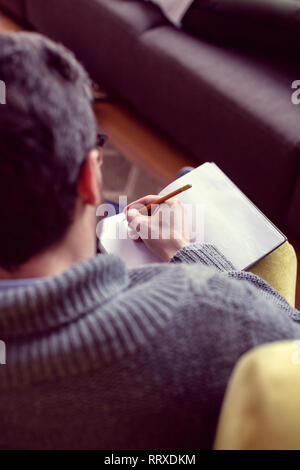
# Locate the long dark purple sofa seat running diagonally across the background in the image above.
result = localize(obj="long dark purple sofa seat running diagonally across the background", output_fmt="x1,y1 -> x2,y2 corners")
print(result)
0,0 -> 300,236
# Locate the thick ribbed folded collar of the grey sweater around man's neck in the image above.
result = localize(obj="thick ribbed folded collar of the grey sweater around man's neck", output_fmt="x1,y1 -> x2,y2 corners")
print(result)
0,255 -> 128,339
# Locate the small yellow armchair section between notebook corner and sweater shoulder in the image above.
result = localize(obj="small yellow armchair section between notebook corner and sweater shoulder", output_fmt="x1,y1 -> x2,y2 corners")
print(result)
250,242 -> 297,307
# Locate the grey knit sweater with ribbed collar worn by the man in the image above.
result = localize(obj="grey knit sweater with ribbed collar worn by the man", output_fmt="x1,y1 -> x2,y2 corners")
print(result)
0,245 -> 300,449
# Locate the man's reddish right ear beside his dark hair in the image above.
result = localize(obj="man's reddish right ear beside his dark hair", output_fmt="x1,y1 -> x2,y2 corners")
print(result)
78,150 -> 101,206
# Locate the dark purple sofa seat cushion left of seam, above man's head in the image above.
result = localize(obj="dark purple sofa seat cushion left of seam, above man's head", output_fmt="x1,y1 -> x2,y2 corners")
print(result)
27,0 -> 167,95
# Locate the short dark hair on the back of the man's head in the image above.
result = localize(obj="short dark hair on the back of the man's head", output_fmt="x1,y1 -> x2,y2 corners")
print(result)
0,33 -> 96,270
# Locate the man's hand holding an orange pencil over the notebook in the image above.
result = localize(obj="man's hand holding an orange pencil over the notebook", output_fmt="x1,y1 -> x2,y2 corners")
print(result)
125,195 -> 190,261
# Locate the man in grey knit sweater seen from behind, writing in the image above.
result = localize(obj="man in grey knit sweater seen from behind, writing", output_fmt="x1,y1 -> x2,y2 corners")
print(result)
0,33 -> 300,449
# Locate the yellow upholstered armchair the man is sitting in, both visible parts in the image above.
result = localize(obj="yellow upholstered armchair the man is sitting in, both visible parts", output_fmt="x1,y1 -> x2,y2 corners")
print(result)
214,242 -> 300,449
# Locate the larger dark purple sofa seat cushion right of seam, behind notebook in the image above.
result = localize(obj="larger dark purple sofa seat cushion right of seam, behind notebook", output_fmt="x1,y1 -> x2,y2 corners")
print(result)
134,27 -> 300,225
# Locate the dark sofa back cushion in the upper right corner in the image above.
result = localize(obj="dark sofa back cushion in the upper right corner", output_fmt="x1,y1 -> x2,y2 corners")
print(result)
182,0 -> 300,56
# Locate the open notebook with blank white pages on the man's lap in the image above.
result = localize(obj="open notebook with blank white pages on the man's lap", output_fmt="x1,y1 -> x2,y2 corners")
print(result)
99,163 -> 286,270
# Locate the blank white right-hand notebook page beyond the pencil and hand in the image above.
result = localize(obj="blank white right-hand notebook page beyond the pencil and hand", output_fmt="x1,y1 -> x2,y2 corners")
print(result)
161,163 -> 286,269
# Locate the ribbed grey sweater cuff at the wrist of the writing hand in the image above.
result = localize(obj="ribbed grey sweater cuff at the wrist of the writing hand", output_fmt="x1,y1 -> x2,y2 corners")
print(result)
170,243 -> 235,271
